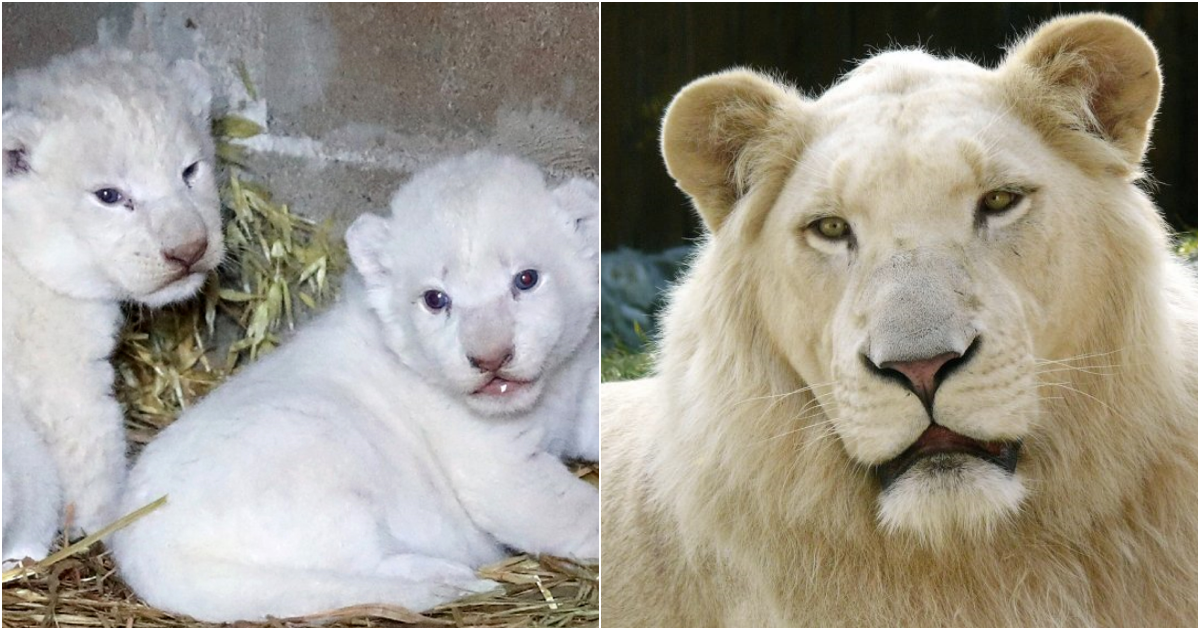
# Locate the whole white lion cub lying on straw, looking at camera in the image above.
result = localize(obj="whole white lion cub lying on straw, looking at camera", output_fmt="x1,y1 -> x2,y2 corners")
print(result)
113,152 -> 599,620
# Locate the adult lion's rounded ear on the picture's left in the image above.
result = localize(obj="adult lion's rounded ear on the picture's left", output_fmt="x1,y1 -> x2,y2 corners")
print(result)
662,70 -> 802,232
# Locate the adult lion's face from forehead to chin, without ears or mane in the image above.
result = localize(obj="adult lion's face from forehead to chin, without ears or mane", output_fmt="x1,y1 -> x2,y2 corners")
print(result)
754,53 -> 1061,533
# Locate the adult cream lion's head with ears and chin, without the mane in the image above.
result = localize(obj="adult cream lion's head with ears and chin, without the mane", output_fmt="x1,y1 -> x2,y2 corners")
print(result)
664,15 -> 1158,541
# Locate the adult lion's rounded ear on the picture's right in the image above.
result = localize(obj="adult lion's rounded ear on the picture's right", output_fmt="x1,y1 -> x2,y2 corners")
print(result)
1002,13 -> 1163,167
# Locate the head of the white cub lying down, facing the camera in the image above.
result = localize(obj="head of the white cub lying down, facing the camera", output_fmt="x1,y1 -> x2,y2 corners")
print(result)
347,154 -> 598,415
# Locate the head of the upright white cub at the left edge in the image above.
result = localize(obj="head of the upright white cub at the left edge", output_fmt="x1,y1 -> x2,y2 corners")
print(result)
4,52 -> 224,306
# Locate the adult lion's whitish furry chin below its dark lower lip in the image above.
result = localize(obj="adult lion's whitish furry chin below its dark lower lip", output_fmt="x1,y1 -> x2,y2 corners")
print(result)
878,452 -> 1025,546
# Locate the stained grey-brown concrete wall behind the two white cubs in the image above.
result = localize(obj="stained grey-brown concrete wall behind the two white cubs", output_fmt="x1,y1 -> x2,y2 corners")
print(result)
4,2 -> 600,226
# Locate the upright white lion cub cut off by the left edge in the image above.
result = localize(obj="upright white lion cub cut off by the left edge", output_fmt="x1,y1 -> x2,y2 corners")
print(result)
2,49 -> 224,559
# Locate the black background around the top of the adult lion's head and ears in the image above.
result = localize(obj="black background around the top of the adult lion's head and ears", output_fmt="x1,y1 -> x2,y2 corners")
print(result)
600,2 -> 1196,251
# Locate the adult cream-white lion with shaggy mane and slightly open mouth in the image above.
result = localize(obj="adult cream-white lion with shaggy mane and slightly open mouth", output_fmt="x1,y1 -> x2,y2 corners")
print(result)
601,14 -> 1196,626
